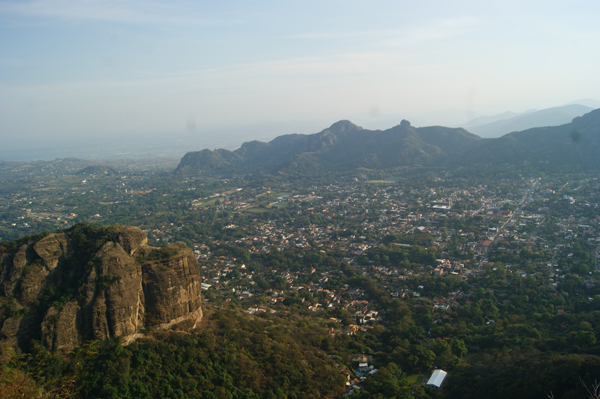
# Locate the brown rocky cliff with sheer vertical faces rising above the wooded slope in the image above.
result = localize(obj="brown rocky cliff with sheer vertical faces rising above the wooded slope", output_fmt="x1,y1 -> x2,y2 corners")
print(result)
0,225 -> 202,352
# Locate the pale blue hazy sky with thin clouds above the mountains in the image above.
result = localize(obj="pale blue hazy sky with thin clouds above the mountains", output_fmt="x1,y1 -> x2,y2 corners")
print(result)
0,0 -> 600,160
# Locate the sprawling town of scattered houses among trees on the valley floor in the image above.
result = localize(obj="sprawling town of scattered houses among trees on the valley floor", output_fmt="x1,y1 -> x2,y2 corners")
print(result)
0,160 -> 600,393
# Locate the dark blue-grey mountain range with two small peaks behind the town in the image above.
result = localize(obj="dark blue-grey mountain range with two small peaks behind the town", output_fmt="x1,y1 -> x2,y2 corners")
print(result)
175,109 -> 600,174
